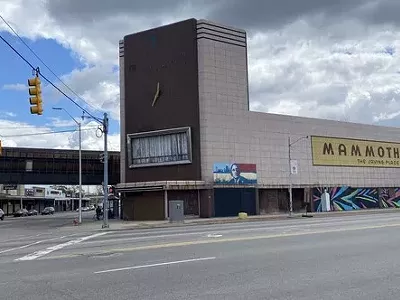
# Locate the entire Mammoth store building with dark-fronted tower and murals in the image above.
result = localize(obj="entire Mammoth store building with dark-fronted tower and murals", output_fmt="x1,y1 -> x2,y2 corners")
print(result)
117,19 -> 400,220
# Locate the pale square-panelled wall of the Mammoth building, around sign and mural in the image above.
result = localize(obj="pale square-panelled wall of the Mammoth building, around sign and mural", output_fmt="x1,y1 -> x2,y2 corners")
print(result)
198,21 -> 400,187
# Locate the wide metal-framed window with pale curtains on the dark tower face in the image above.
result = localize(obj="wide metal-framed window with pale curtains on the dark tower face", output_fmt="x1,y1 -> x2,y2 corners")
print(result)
127,127 -> 192,168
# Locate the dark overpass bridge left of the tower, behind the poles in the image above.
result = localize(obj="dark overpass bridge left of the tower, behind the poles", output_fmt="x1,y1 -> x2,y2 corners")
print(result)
0,147 -> 120,185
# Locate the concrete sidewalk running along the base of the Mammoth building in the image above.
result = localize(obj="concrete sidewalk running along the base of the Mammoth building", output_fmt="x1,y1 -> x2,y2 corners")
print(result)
60,208 -> 400,231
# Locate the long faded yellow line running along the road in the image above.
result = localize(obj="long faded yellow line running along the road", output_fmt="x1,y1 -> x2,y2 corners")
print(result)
39,223 -> 400,259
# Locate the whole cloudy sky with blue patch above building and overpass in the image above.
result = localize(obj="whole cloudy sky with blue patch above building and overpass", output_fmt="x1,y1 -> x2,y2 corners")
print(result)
0,0 -> 400,149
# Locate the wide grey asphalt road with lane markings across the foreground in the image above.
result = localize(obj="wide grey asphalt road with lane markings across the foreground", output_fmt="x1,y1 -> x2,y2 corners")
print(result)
0,213 -> 400,300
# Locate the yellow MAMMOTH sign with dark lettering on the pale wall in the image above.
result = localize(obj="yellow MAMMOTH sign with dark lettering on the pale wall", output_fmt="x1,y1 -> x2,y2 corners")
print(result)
311,136 -> 400,168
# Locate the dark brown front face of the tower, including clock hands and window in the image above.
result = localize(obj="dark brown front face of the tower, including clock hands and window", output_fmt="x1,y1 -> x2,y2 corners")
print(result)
120,19 -> 201,183
